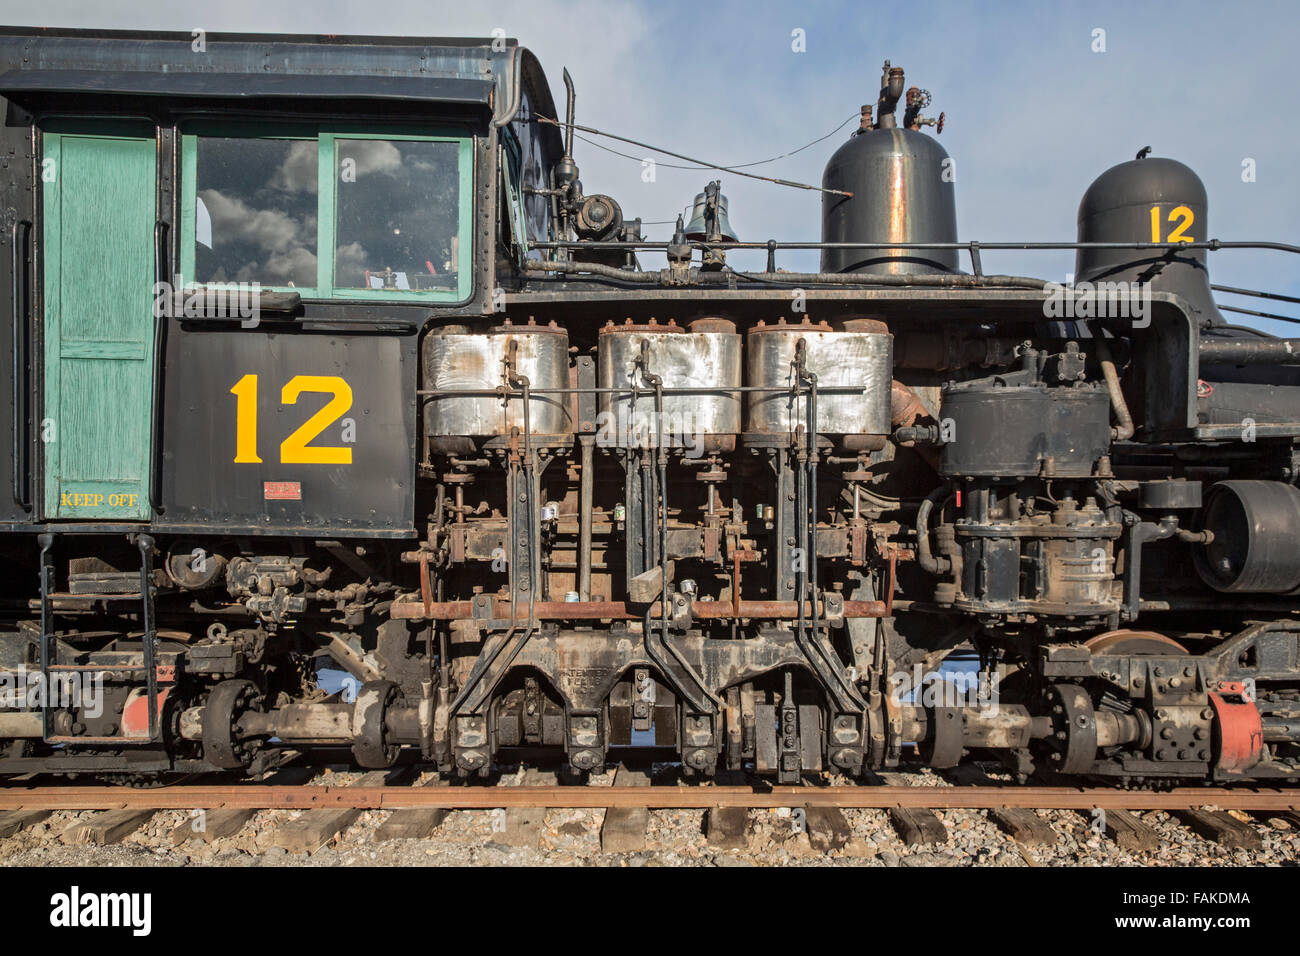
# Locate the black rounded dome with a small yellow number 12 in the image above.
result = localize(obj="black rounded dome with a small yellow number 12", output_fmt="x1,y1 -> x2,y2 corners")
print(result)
1074,156 -> 1225,325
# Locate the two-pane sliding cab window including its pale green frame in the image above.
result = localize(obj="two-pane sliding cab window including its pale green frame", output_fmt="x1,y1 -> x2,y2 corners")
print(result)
181,125 -> 473,302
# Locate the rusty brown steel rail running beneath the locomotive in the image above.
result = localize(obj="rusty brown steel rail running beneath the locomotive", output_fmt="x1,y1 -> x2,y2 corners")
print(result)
0,783 -> 1300,810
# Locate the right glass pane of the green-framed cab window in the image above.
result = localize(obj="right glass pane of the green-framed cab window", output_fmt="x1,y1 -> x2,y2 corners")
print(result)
334,138 -> 460,291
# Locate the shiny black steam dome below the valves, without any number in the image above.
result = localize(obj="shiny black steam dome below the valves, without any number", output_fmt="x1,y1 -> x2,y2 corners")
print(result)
822,126 -> 958,276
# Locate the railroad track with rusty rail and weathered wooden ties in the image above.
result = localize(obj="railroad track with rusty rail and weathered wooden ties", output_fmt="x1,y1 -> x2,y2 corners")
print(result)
0,767 -> 1300,865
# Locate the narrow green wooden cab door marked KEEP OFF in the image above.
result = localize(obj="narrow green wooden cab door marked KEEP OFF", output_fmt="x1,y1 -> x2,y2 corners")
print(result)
40,124 -> 157,520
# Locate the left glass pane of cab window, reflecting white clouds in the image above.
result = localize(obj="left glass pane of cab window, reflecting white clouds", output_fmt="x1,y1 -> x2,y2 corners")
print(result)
194,137 -> 317,289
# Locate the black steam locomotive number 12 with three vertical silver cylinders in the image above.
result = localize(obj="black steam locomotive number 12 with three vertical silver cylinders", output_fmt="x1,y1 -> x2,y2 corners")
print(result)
0,29 -> 1300,786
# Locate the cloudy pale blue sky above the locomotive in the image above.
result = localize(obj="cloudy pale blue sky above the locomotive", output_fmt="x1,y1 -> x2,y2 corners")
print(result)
0,0 -> 1300,332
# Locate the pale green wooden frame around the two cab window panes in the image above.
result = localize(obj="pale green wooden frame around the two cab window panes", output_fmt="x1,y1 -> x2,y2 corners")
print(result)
178,120 -> 475,303
